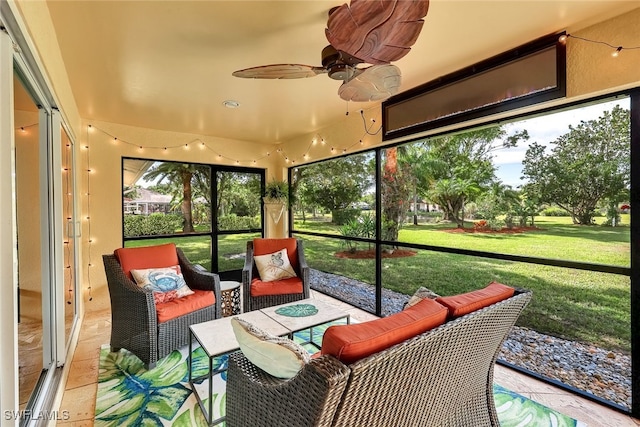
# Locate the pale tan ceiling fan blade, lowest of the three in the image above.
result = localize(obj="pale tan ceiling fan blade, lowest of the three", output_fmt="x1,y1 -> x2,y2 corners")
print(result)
338,64 -> 401,102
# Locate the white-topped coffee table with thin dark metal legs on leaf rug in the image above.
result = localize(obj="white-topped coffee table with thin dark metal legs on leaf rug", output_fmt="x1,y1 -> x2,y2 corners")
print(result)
187,298 -> 350,426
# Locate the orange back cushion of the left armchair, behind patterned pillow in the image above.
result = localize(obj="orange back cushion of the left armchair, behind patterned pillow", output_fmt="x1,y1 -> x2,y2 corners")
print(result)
113,243 -> 179,280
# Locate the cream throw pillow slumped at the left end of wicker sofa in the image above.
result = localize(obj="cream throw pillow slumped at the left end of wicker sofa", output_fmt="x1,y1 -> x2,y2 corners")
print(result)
231,317 -> 311,378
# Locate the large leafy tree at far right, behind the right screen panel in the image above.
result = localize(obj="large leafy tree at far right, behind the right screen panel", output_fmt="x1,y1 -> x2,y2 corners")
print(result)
522,106 -> 630,224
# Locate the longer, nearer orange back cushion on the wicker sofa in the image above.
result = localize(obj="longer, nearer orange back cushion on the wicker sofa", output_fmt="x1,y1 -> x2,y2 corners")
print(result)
321,299 -> 447,364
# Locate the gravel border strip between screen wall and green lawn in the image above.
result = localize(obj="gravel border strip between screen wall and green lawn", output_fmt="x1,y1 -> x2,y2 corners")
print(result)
310,269 -> 631,409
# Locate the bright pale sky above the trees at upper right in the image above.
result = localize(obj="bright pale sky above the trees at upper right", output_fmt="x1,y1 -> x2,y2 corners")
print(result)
493,98 -> 630,188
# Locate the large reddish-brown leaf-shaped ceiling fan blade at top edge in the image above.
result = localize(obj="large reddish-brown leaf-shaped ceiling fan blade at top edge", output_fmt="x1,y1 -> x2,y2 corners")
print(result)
325,0 -> 429,64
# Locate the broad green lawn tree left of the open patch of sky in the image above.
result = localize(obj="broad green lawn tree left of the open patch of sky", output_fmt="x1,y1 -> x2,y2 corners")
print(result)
417,126 -> 529,228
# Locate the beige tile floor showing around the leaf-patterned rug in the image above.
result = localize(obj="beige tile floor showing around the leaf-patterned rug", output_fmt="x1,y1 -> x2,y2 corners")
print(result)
58,291 -> 640,427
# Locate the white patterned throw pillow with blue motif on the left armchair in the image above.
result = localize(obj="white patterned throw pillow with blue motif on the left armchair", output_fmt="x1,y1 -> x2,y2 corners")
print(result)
131,265 -> 194,304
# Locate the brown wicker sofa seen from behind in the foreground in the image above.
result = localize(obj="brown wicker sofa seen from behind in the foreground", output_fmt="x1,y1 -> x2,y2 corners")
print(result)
226,290 -> 531,427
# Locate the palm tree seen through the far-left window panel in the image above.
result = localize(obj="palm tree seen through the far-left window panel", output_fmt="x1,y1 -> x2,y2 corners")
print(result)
143,162 -> 209,233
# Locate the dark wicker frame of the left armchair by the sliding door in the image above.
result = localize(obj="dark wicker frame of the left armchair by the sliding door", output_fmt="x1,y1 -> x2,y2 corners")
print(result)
102,245 -> 222,369
